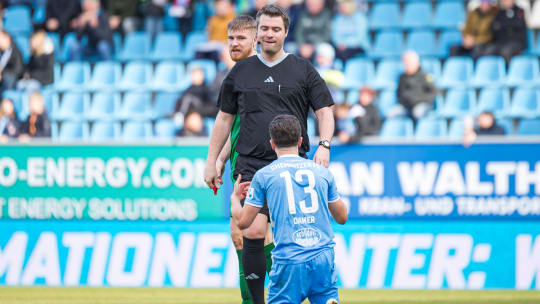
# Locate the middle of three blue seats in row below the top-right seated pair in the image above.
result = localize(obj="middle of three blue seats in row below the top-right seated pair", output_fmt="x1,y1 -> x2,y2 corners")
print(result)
469,56 -> 506,88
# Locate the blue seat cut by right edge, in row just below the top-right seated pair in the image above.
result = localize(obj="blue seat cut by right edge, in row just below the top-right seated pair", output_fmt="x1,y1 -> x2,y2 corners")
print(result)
506,56 -> 540,87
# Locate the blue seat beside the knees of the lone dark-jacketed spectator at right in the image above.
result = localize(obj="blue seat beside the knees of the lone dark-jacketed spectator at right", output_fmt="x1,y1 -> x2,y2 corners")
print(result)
439,89 -> 476,117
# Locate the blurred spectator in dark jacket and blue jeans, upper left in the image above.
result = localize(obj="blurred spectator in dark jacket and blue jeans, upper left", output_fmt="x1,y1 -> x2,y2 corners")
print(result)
71,0 -> 113,60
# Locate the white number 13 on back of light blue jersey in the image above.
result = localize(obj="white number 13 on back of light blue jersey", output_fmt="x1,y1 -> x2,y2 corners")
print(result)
279,170 -> 319,214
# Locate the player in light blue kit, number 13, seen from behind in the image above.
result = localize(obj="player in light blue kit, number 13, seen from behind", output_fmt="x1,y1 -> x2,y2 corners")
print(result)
231,115 -> 347,304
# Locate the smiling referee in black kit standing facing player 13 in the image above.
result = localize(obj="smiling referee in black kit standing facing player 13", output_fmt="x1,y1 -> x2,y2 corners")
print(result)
204,4 -> 334,304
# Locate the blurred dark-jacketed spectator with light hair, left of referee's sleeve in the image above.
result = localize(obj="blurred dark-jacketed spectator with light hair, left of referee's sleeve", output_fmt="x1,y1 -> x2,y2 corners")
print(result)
173,67 -> 218,125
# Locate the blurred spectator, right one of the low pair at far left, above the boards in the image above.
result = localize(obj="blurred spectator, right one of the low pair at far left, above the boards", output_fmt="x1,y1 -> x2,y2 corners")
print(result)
20,92 -> 51,140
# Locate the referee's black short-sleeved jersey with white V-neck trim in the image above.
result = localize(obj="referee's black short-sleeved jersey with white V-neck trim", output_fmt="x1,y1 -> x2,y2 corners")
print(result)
218,54 -> 334,160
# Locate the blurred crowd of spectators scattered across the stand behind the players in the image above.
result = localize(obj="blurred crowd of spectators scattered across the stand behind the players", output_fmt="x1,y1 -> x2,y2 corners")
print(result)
0,0 -> 527,142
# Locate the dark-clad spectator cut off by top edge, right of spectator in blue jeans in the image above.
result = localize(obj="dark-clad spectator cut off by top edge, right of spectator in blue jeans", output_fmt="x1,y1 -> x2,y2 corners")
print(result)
107,0 -> 140,35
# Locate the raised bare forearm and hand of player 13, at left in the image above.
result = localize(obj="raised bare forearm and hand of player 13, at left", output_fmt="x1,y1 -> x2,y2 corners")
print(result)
231,175 -> 261,230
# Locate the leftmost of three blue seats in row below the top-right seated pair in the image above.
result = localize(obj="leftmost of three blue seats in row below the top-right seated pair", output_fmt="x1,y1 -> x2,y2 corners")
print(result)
437,57 -> 473,88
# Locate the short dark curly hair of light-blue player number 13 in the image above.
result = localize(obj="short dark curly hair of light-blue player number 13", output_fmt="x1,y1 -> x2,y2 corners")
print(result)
269,114 -> 302,148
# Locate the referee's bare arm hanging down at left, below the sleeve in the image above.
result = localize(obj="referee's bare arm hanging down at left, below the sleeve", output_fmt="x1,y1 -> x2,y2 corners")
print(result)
204,111 -> 234,189
